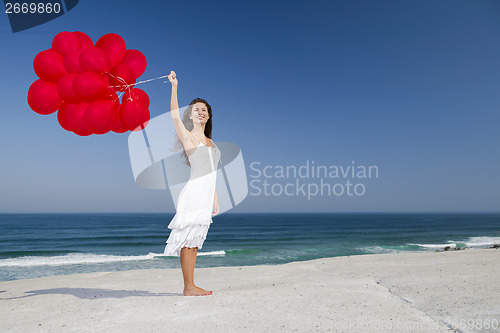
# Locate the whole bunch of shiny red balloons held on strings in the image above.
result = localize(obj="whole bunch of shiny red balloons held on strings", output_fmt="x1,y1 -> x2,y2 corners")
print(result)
28,31 -> 150,136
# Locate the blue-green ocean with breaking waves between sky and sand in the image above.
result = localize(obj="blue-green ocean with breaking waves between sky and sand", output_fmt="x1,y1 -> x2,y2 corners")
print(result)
0,213 -> 500,281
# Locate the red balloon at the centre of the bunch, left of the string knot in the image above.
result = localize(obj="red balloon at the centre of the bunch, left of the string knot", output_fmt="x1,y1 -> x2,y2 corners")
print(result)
73,72 -> 108,102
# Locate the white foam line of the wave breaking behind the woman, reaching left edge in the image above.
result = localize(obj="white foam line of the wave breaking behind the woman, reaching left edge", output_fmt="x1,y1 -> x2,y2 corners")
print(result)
0,251 -> 226,267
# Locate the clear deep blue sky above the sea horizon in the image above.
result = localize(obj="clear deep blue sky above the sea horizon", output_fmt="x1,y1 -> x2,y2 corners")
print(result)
0,0 -> 500,212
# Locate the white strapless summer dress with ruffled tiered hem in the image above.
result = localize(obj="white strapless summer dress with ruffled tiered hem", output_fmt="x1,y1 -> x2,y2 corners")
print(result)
163,136 -> 220,256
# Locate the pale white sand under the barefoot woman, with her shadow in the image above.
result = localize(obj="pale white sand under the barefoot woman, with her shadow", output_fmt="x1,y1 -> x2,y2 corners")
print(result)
0,249 -> 500,333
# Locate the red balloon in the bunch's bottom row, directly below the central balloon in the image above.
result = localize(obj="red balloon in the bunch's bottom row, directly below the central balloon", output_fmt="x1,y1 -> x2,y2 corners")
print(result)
85,100 -> 115,134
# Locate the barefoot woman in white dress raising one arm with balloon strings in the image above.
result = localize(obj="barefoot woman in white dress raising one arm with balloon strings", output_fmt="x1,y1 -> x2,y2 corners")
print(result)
164,71 -> 220,296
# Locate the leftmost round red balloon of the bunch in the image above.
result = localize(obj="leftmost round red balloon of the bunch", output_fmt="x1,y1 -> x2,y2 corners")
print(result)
28,79 -> 63,114
